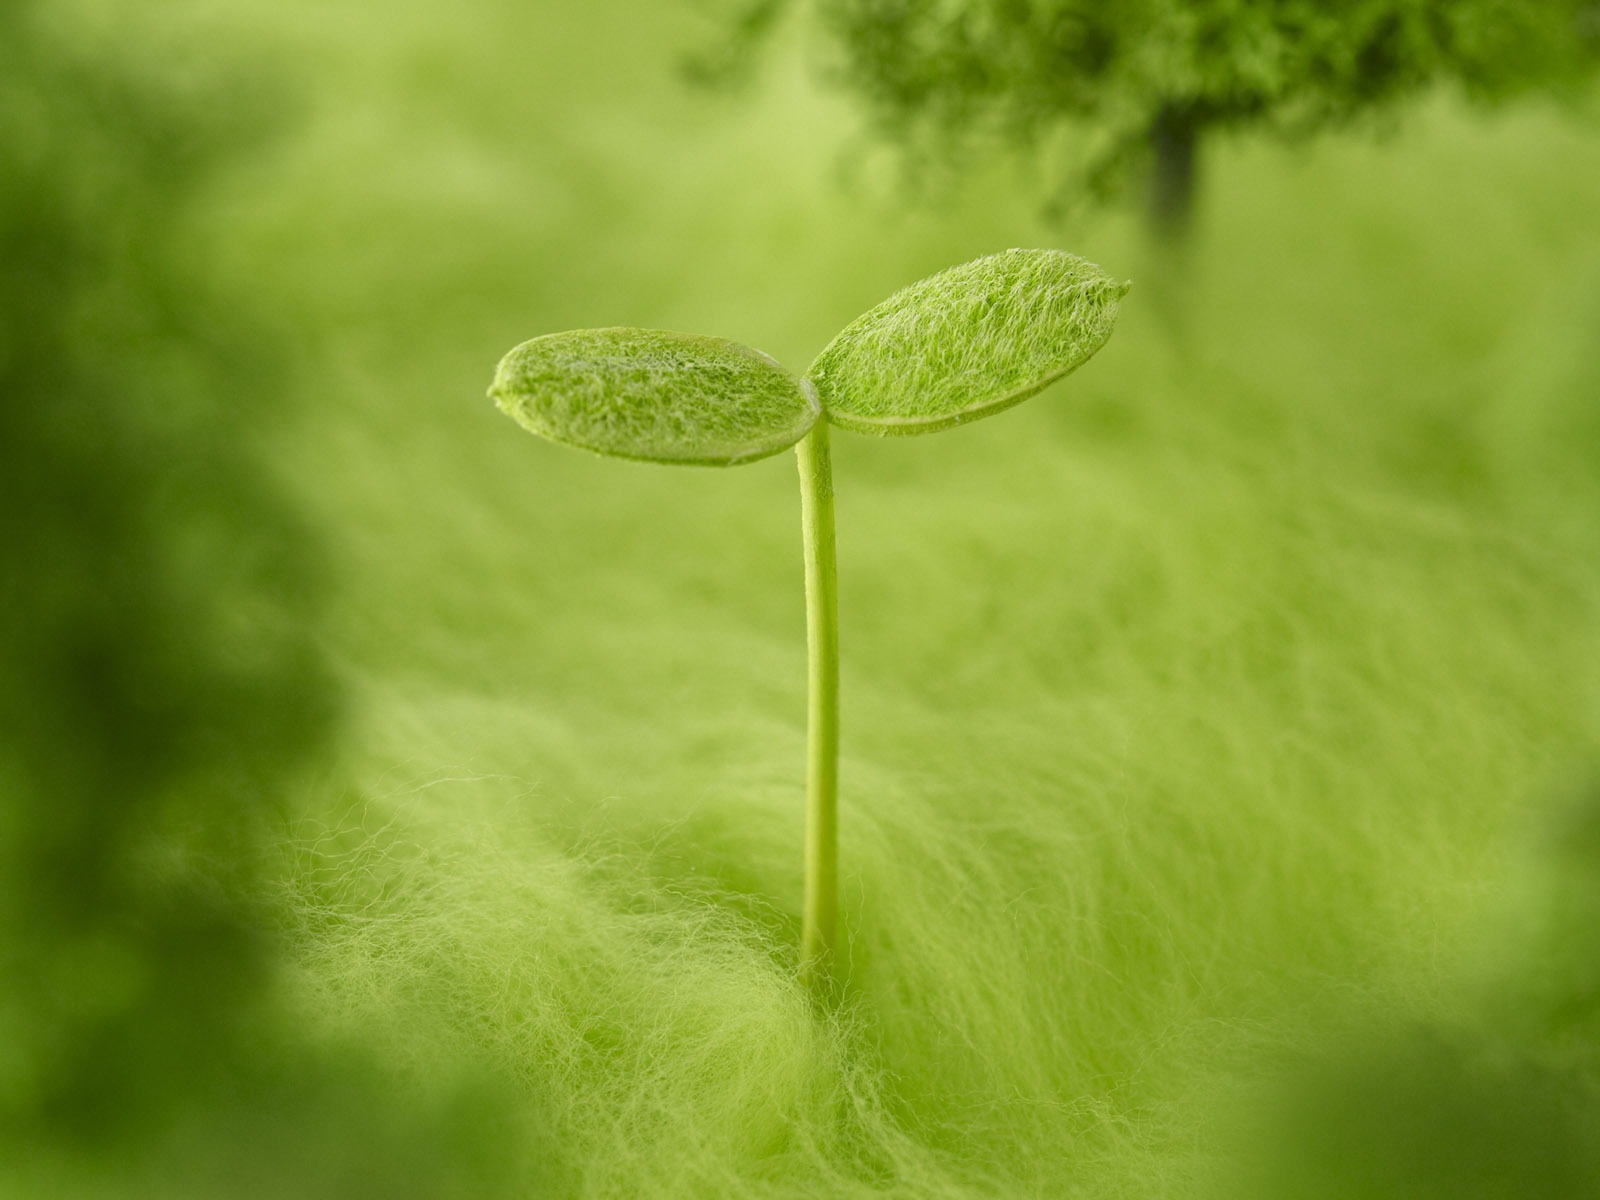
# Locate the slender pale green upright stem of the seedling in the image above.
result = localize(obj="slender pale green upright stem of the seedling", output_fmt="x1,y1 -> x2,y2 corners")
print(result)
795,419 -> 838,998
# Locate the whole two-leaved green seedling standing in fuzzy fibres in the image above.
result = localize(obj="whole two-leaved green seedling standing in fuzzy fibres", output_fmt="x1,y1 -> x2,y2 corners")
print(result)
490,250 -> 1128,997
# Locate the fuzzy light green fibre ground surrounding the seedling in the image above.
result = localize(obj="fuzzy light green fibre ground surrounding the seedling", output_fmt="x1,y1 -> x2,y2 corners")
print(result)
46,0 -> 1600,1197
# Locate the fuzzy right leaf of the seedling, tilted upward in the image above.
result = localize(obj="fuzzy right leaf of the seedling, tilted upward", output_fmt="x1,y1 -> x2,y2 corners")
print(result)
806,250 -> 1128,434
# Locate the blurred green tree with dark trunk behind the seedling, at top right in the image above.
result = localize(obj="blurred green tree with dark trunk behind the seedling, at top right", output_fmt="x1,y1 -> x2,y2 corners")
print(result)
694,0 -> 1600,246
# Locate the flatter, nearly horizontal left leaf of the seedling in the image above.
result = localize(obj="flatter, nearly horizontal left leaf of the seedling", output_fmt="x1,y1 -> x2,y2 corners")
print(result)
490,328 -> 819,467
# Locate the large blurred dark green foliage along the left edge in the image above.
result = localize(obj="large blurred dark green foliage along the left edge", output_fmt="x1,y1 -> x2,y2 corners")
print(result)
0,9 -> 560,1200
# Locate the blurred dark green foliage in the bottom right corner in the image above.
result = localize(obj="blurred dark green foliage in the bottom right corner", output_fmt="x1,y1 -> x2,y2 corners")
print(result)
1245,787 -> 1600,1200
